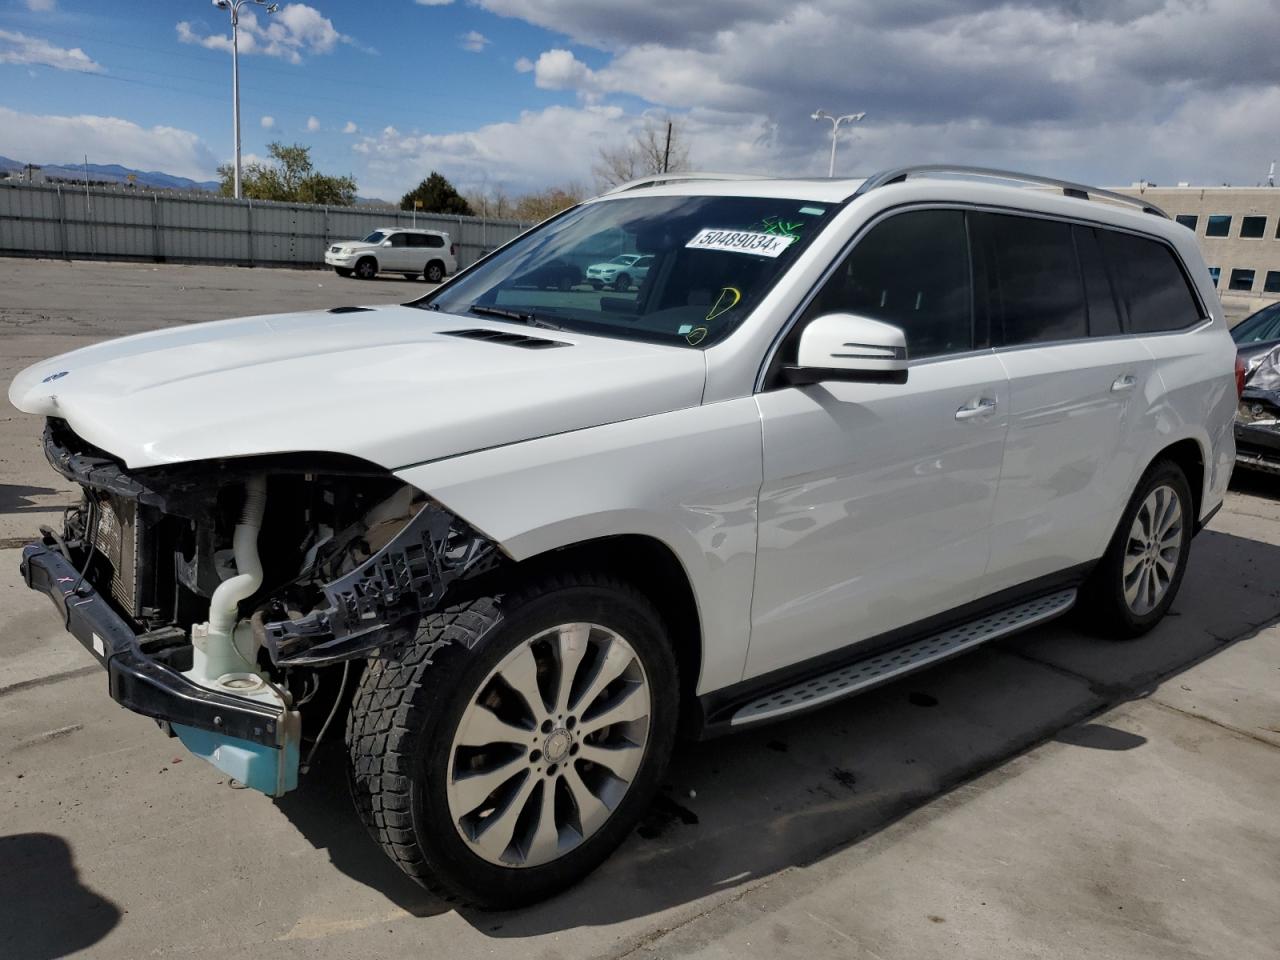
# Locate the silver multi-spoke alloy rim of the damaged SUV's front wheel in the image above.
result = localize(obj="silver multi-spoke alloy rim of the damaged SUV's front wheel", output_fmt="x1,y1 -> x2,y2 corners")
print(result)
445,623 -> 653,867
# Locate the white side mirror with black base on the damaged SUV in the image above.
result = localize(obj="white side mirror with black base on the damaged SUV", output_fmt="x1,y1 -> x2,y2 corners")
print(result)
782,314 -> 906,387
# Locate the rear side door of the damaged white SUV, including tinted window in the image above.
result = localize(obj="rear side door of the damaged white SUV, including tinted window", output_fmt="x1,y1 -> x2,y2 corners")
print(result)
972,212 -> 1158,591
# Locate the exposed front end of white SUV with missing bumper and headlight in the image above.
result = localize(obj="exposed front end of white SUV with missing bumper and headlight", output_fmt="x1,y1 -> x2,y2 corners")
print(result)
22,419 -> 503,796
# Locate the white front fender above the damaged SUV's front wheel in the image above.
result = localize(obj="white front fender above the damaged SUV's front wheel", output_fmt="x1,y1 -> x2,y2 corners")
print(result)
397,397 -> 763,694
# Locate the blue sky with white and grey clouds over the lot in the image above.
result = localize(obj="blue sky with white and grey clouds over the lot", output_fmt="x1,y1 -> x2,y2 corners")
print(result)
0,0 -> 1280,200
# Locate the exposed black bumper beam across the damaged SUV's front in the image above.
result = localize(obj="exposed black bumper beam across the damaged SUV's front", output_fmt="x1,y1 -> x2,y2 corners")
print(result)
20,543 -> 283,748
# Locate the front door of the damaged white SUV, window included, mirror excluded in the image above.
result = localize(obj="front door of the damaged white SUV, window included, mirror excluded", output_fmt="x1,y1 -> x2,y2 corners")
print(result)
746,210 -> 1009,677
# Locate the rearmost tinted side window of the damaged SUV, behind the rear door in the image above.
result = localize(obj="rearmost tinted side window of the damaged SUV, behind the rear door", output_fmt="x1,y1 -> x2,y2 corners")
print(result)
1100,230 -> 1203,333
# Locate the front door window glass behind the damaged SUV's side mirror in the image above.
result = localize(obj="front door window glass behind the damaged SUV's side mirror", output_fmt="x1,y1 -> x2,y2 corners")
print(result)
800,210 -> 974,358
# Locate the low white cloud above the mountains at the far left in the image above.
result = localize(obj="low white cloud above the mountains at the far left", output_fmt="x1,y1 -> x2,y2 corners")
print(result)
0,106 -> 218,180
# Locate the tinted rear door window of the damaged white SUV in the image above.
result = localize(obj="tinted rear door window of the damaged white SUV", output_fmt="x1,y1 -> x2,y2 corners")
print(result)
972,214 -> 1088,346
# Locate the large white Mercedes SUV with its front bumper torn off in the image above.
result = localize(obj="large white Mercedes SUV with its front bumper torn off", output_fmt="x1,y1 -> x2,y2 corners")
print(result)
9,168 -> 1238,906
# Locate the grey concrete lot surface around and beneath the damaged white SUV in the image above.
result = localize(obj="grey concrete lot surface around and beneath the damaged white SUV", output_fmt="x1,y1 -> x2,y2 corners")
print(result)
0,260 -> 1280,960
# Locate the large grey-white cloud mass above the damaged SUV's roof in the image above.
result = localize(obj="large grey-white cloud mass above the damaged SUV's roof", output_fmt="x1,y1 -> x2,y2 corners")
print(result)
475,0 -> 1280,183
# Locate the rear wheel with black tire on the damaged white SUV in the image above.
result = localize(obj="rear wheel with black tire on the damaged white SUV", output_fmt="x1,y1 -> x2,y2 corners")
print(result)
1080,460 -> 1196,640
